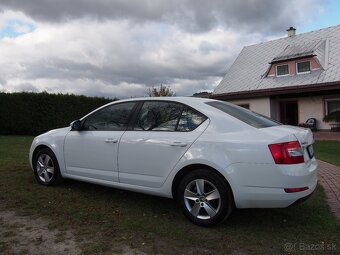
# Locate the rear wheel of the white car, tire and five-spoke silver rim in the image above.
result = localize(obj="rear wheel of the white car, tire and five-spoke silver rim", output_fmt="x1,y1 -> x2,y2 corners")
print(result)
177,169 -> 234,227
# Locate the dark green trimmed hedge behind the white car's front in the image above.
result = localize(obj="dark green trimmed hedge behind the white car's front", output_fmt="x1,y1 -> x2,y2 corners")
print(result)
0,92 -> 112,135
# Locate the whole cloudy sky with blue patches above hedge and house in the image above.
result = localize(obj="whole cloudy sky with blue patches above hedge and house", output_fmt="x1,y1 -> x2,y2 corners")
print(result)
0,0 -> 340,98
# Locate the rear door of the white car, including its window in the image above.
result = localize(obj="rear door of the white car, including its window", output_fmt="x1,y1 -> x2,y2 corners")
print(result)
118,101 -> 208,187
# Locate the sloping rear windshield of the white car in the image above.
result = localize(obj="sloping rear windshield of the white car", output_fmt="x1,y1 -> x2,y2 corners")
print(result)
206,102 -> 282,128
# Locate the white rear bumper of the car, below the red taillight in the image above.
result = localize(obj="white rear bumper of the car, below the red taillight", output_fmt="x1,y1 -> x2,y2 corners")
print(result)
227,158 -> 317,208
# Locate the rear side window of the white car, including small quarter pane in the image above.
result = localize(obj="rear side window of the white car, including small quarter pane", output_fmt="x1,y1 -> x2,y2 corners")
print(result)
133,101 -> 206,132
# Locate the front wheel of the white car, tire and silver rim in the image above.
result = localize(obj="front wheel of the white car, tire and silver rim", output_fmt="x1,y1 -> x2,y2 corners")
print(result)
33,148 -> 62,186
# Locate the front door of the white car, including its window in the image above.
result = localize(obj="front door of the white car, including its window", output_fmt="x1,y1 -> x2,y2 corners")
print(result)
64,102 -> 136,182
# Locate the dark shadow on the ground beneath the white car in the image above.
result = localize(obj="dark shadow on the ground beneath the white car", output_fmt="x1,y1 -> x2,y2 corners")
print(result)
56,180 -> 323,230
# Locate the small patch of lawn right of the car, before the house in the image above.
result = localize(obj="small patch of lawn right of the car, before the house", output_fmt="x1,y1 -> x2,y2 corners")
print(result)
314,141 -> 340,166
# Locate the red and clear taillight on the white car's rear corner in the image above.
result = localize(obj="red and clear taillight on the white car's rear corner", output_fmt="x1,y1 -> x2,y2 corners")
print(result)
268,141 -> 304,164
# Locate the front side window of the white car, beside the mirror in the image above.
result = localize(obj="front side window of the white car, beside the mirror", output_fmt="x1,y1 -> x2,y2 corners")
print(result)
82,102 -> 135,131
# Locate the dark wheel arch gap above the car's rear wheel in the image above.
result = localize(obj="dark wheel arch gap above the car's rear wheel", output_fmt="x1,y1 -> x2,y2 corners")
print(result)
171,164 -> 235,205
